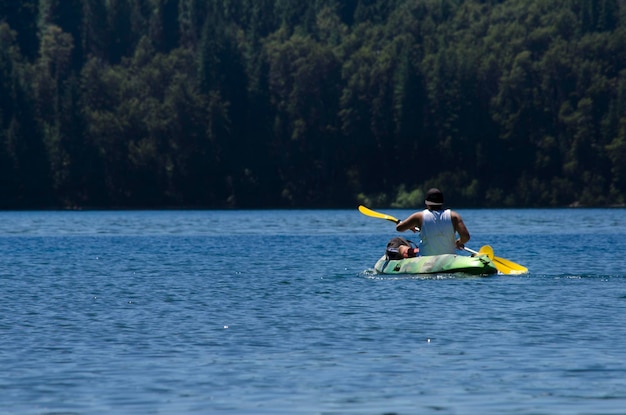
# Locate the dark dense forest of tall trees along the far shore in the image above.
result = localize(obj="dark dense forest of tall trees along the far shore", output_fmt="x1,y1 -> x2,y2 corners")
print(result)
0,0 -> 626,209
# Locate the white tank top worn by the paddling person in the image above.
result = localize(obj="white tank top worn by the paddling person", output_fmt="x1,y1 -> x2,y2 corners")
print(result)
420,209 -> 456,256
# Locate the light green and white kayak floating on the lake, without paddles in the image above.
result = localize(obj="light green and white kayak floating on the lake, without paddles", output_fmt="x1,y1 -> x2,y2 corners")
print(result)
374,254 -> 498,275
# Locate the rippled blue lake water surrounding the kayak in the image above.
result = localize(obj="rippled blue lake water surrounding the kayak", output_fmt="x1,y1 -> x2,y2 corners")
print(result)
0,209 -> 626,415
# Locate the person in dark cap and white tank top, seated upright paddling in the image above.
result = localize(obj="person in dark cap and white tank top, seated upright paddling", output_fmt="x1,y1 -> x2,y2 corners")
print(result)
396,188 -> 470,256
